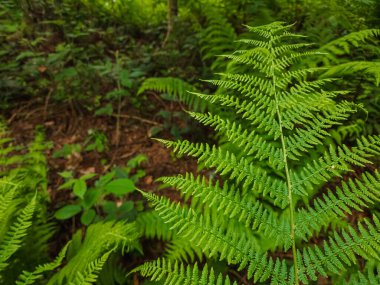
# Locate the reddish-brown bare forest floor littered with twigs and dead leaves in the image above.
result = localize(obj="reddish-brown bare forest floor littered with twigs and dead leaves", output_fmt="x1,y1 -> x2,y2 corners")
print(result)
6,95 -> 202,242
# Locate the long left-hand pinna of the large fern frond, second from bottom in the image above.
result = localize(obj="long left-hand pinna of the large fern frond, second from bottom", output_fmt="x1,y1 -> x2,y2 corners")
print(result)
143,190 -> 287,284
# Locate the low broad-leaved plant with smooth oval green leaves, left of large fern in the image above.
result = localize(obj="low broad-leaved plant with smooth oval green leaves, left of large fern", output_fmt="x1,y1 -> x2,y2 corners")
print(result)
54,155 -> 147,225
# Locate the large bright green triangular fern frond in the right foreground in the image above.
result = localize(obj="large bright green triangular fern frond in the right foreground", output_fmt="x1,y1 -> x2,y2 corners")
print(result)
136,22 -> 380,285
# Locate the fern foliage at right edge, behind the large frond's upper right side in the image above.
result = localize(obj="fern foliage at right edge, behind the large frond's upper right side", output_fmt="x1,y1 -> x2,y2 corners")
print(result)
305,29 -> 380,138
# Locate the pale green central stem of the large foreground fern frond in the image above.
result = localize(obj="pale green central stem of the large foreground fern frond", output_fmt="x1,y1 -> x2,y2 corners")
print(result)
272,57 -> 299,285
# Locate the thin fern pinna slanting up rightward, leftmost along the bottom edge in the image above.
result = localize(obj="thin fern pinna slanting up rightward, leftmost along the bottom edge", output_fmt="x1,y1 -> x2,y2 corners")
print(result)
16,242 -> 70,285
